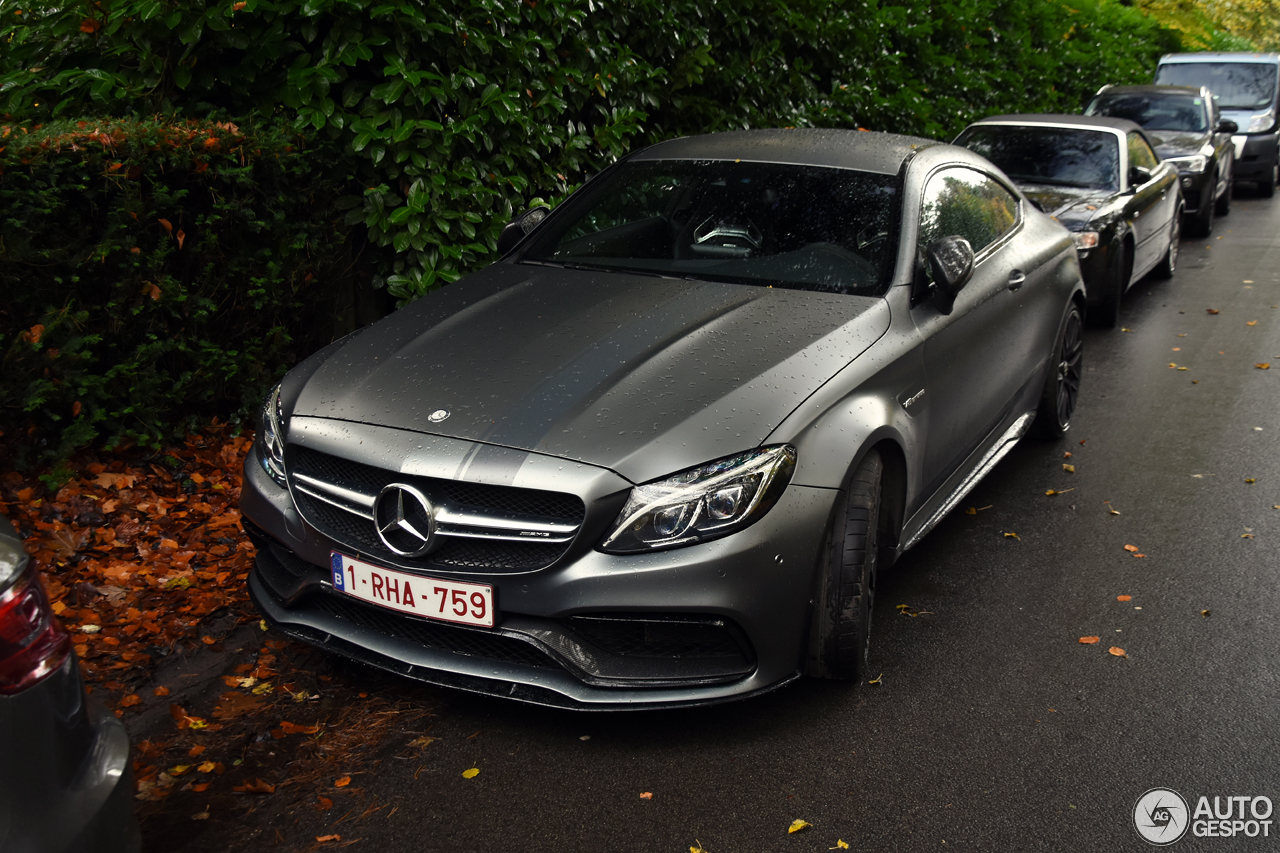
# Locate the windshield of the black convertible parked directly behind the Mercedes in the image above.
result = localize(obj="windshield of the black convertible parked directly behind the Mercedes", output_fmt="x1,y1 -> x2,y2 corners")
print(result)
956,124 -> 1120,190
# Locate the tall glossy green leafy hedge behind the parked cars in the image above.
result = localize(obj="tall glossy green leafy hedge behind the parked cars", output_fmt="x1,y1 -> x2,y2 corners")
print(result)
0,0 -> 1178,300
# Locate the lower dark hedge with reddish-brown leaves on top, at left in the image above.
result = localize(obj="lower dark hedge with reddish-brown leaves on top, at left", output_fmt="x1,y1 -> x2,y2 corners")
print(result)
0,119 -> 376,462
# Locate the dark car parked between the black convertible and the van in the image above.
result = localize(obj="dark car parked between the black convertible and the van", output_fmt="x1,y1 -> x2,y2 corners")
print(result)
1084,86 -> 1239,237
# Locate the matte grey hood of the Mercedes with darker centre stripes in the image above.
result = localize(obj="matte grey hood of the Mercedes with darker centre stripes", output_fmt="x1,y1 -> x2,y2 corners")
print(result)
285,264 -> 890,482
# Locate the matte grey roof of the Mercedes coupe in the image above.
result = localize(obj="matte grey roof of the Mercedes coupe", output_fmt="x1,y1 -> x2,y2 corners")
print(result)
628,128 -> 943,174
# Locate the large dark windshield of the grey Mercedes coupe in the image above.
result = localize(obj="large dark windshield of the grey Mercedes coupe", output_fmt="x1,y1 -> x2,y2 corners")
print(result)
520,160 -> 900,296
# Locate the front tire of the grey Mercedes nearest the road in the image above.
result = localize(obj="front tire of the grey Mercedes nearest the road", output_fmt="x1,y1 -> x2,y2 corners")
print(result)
808,450 -> 884,680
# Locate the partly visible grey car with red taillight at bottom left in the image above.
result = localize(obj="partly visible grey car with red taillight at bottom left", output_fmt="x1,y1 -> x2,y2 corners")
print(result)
0,516 -> 140,853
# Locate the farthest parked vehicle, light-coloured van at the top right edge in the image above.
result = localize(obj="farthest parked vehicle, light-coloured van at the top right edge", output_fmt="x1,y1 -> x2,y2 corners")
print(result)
1156,51 -> 1280,199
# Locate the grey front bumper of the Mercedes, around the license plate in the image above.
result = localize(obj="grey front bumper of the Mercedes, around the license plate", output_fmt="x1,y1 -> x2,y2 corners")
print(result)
242,440 -> 836,710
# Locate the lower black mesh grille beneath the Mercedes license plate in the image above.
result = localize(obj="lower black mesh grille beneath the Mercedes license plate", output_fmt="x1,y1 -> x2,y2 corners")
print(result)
316,593 -> 559,669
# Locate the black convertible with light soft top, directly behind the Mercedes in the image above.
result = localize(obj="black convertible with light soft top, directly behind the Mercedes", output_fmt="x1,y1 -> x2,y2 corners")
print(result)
956,114 -> 1183,328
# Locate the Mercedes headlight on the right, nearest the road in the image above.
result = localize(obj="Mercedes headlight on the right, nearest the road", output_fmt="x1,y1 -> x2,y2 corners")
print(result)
600,444 -> 796,553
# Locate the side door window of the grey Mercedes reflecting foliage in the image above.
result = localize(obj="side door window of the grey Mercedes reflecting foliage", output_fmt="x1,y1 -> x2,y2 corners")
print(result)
919,168 -> 1018,252
